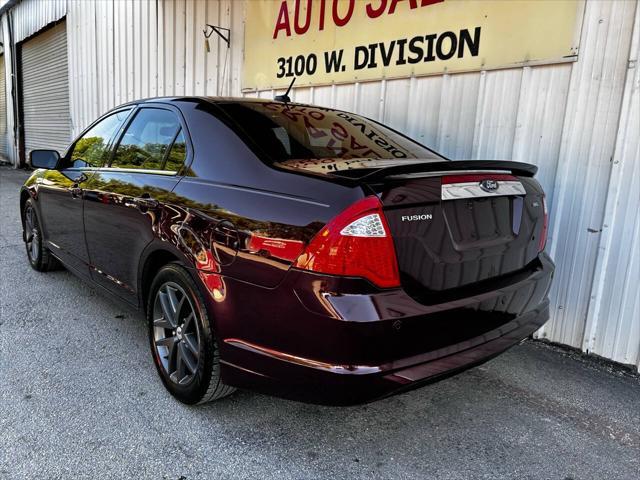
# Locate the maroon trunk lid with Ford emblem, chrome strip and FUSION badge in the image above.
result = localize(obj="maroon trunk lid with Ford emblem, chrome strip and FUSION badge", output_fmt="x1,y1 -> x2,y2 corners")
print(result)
364,161 -> 545,301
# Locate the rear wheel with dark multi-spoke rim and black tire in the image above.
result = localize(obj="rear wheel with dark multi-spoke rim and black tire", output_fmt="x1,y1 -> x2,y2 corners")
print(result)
147,263 -> 235,405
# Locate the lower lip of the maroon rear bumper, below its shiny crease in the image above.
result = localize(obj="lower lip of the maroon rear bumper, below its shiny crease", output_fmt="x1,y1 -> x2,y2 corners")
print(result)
223,303 -> 549,405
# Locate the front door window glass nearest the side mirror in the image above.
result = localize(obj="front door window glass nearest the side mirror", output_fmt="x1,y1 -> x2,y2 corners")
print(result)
66,109 -> 130,168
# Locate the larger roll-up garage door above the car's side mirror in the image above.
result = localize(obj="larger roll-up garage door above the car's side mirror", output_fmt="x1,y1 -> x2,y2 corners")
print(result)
20,22 -> 71,156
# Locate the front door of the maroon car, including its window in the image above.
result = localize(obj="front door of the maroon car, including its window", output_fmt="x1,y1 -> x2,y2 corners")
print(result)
38,108 -> 131,276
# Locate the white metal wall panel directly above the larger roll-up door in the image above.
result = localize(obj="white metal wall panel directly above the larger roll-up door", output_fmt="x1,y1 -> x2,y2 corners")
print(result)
12,0 -> 67,43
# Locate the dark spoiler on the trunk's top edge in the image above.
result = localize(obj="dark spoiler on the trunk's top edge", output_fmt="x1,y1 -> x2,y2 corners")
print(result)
338,160 -> 538,181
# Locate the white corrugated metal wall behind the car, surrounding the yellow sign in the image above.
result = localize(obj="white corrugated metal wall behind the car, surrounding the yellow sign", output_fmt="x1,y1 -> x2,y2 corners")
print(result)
0,0 -> 640,372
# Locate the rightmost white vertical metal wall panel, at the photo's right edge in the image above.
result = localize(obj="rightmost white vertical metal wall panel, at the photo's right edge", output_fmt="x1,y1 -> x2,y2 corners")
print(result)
582,5 -> 640,370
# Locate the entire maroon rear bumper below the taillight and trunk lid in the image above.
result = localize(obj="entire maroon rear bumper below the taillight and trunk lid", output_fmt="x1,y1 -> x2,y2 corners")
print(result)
212,254 -> 553,405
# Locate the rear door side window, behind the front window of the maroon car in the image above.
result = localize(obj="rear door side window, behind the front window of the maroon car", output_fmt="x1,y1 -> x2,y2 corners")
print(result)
111,108 -> 186,172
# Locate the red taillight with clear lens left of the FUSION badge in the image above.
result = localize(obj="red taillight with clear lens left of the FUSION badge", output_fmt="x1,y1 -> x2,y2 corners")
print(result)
295,196 -> 400,288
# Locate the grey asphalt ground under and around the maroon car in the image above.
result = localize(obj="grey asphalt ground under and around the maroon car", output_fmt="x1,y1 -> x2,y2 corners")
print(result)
0,167 -> 640,480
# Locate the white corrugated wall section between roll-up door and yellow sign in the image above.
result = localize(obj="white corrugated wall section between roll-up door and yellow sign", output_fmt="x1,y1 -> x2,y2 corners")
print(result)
67,0 -> 244,133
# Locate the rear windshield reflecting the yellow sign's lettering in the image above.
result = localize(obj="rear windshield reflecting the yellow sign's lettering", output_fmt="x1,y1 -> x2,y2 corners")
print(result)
218,102 -> 443,163
